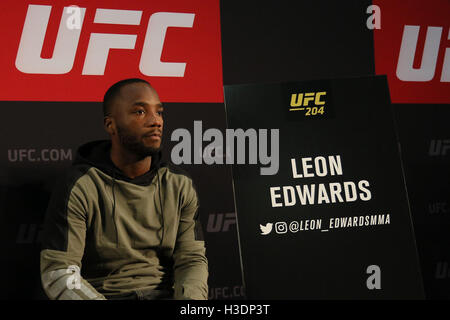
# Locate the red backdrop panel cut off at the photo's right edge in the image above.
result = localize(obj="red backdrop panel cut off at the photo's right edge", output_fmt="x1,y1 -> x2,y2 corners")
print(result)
373,0 -> 450,104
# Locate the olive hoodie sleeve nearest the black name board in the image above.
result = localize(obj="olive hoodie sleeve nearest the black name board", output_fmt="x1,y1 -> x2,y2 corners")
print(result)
174,179 -> 208,300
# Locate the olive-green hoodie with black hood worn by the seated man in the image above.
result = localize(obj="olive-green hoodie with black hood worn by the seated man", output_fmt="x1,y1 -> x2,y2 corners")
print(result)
41,140 -> 208,299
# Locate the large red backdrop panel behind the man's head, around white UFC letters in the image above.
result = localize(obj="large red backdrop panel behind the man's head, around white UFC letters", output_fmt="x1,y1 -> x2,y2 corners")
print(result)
0,0 -> 223,102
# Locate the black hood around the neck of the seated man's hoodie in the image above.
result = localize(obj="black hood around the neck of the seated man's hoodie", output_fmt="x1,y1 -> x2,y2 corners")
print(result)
72,140 -> 165,185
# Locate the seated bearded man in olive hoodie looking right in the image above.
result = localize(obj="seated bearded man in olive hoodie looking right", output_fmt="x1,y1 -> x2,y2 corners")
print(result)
41,79 -> 208,299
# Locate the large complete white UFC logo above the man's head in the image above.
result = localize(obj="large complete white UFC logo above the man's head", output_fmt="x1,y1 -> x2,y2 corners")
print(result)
16,5 -> 195,77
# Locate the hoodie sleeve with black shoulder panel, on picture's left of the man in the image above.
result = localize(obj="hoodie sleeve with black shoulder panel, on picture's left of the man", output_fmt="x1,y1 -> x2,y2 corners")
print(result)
40,172 -> 105,300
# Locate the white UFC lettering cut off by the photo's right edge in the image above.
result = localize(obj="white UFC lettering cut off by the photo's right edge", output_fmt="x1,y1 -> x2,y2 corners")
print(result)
397,25 -> 450,82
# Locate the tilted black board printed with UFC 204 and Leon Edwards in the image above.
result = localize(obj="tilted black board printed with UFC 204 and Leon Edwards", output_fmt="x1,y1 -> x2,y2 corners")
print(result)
224,76 -> 424,299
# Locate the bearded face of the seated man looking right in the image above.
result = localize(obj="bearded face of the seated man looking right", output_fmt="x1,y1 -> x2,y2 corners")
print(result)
113,83 -> 163,158
